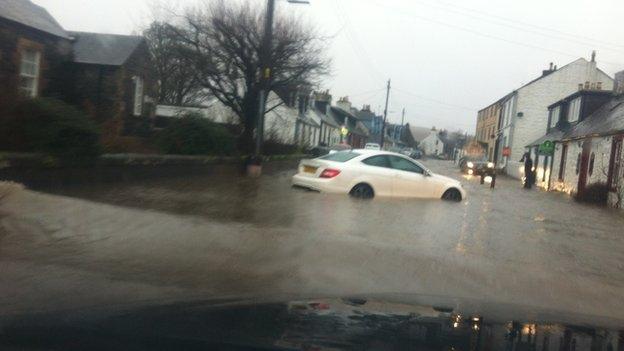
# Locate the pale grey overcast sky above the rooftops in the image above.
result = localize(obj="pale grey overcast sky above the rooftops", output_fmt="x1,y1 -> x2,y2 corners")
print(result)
33,0 -> 624,132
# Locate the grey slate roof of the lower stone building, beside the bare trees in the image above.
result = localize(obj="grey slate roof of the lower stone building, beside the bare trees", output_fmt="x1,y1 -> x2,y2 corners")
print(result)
70,32 -> 144,66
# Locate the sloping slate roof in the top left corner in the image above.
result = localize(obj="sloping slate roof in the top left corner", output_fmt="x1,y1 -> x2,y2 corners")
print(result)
0,0 -> 69,39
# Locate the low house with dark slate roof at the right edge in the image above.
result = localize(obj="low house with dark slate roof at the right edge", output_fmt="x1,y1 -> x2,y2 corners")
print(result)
529,72 -> 624,208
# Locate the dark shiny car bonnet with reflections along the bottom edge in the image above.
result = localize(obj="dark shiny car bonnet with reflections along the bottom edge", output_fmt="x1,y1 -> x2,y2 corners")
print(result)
0,298 -> 624,351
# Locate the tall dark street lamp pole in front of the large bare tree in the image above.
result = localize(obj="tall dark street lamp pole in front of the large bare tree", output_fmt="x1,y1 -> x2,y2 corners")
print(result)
247,0 -> 310,176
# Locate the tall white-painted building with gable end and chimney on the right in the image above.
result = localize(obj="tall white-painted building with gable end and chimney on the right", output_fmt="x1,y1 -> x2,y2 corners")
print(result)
497,58 -> 613,179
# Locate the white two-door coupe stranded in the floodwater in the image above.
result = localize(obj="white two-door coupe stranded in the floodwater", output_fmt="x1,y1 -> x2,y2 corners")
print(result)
292,149 -> 466,201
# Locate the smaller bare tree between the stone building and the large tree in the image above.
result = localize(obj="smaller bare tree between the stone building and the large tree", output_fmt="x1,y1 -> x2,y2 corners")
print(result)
143,21 -> 204,106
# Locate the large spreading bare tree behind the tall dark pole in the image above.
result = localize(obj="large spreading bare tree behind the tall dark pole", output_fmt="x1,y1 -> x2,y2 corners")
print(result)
168,1 -> 330,152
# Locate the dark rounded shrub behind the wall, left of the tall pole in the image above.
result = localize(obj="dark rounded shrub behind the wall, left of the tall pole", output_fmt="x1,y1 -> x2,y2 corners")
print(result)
156,113 -> 235,155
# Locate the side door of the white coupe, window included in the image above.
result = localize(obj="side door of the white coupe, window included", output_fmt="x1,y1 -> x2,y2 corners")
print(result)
388,156 -> 433,197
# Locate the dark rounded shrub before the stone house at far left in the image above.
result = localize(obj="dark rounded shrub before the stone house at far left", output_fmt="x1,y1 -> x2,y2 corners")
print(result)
2,98 -> 101,162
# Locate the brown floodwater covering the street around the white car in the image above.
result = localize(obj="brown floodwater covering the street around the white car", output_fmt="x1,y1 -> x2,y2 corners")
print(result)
0,160 -> 624,325
